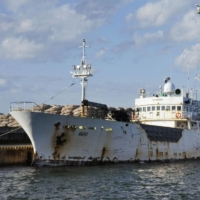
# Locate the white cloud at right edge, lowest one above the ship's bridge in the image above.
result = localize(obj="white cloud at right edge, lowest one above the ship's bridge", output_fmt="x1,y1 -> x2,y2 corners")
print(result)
175,44 -> 200,71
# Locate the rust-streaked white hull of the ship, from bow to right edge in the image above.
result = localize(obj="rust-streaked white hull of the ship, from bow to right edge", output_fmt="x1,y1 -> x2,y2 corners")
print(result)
11,111 -> 200,166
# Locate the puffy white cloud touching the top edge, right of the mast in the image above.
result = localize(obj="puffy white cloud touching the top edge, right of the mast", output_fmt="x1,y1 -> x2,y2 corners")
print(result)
136,0 -> 190,27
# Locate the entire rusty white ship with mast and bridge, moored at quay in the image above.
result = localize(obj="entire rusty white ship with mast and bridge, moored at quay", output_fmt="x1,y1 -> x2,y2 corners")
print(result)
10,40 -> 200,166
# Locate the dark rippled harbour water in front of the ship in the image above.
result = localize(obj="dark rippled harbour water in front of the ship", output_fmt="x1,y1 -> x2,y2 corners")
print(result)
0,161 -> 200,200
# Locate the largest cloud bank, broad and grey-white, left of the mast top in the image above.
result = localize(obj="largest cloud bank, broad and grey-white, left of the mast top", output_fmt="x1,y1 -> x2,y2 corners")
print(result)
0,1 -> 101,62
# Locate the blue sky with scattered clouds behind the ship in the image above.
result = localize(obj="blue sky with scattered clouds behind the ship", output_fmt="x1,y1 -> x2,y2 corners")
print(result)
0,0 -> 200,113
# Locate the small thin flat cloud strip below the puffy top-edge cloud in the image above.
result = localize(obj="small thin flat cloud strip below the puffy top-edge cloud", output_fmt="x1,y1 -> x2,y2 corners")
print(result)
133,31 -> 164,45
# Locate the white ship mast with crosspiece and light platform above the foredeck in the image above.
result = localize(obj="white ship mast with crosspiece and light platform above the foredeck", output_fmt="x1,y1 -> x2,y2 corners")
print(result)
72,39 -> 92,101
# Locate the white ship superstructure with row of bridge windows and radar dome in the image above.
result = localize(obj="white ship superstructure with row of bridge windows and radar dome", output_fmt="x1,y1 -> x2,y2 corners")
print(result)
134,77 -> 200,130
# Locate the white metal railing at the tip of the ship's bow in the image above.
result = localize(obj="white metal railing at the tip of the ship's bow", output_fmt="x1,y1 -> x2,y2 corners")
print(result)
10,101 -> 42,112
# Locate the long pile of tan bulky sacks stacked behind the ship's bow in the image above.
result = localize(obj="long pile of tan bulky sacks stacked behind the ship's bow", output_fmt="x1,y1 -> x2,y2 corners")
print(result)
5,103 -> 133,124
